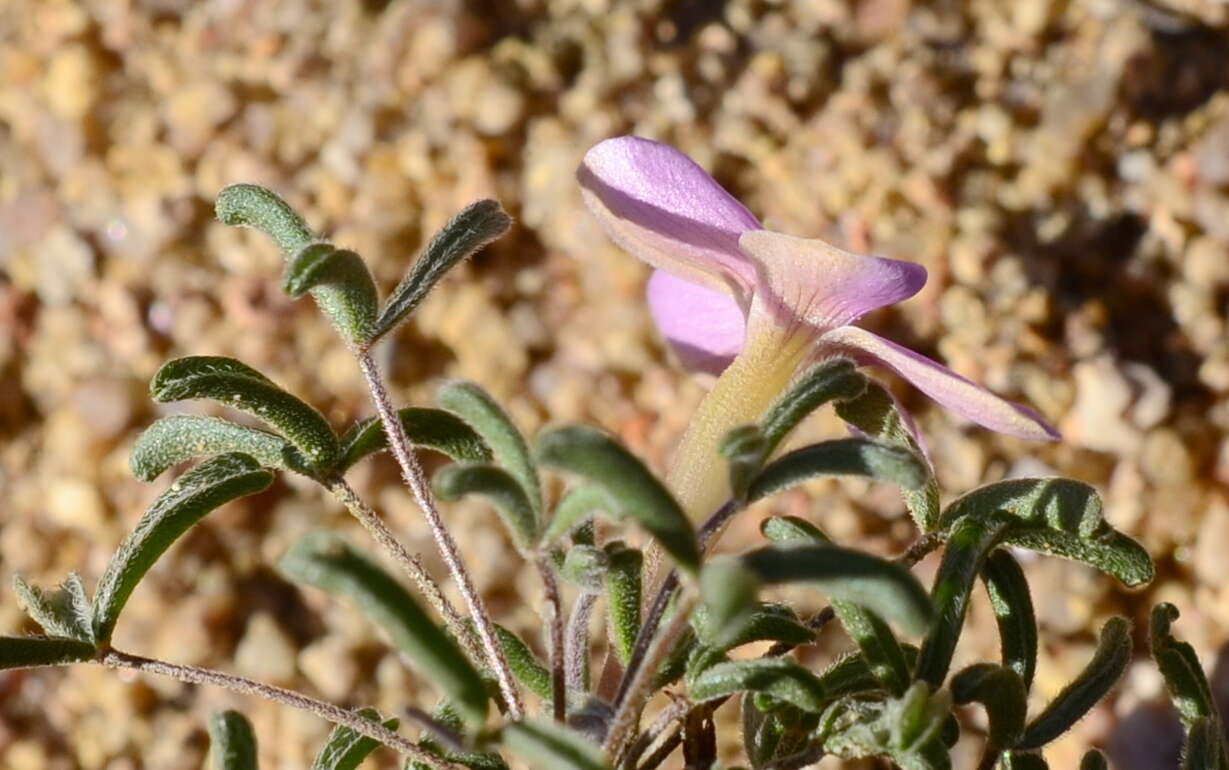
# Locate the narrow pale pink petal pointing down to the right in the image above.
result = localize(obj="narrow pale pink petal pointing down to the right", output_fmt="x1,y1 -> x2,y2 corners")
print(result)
820,327 -> 1059,441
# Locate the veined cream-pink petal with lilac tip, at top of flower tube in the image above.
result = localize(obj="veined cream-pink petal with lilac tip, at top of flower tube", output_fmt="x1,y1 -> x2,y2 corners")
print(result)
739,230 -> 925,333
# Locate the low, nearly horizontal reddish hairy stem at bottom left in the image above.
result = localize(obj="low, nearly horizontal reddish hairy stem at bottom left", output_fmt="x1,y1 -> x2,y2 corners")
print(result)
98,650 -> 462,770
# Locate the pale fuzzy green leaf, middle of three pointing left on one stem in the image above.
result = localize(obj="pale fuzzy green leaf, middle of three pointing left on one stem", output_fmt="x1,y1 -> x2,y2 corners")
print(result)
128,414 -> 311,481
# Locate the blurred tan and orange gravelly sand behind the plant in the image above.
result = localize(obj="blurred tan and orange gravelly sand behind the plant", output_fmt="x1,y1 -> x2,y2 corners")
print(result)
0,0 -> 1229,770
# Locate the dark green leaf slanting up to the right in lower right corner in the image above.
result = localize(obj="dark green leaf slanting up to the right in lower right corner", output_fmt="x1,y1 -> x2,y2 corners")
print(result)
1018,618 -> 1132,749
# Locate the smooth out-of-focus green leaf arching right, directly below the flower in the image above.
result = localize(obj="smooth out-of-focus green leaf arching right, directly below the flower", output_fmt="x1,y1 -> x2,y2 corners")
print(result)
742,545 -> 934,634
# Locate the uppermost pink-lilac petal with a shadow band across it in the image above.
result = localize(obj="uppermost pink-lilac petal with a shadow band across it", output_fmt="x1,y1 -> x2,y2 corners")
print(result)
576,136 -> 760,298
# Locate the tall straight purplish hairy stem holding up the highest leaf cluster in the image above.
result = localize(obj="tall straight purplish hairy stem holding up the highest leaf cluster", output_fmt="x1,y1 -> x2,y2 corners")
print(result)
358,351 -> 525,721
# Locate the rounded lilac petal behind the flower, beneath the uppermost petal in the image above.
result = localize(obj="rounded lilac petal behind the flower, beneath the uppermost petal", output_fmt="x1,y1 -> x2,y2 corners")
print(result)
646,270 -> 746,375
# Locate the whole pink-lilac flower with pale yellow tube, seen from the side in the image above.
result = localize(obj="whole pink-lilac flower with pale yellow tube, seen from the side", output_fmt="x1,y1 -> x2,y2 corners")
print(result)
578,136 -> 1058,516
